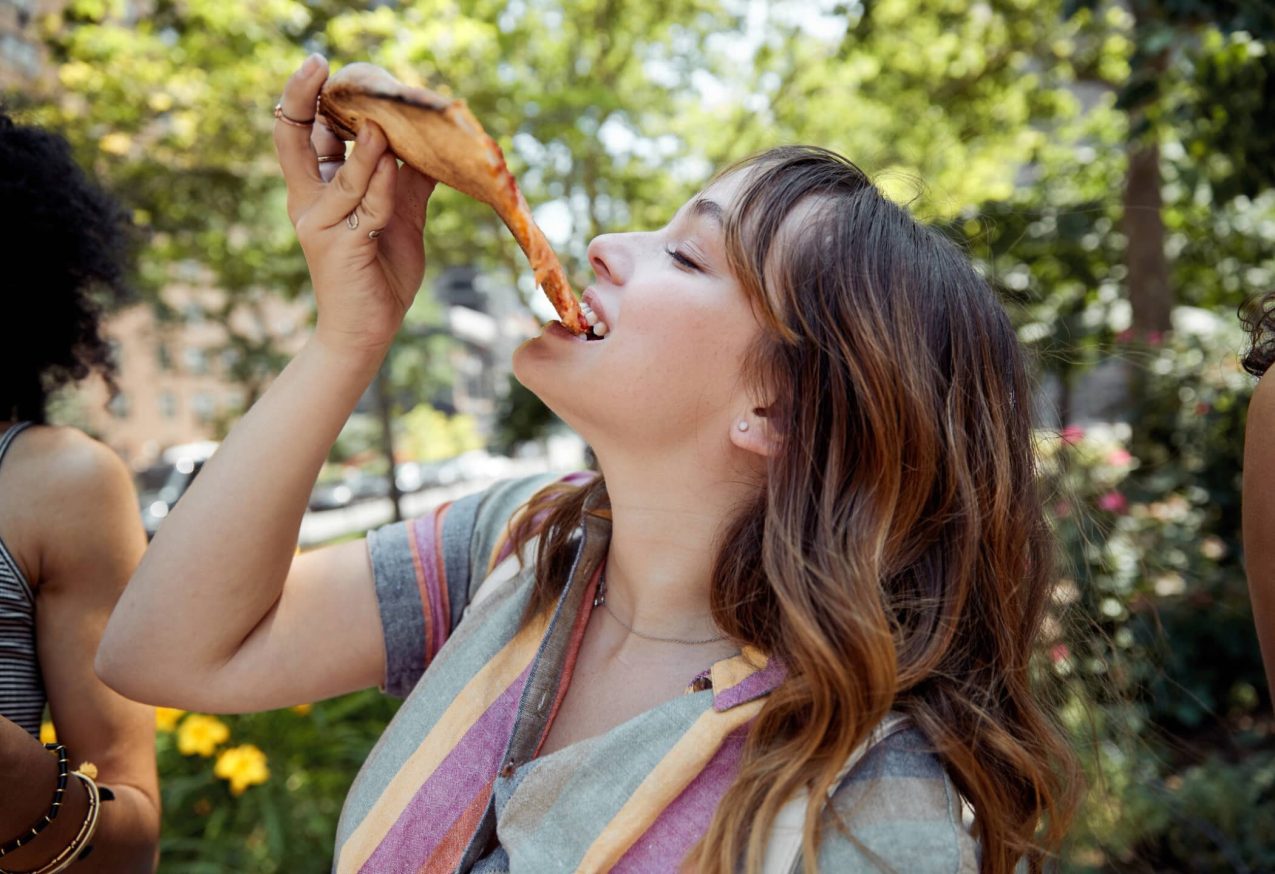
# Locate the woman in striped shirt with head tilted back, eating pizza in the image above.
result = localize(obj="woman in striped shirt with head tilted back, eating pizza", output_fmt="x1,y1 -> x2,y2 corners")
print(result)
98,57 -> 1080,873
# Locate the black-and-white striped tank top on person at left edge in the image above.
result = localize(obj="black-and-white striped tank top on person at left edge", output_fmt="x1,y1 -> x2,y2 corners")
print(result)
0,422 -> 45,737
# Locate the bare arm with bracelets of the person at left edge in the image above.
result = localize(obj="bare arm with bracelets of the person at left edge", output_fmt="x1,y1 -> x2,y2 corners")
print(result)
0,429 -> 159,873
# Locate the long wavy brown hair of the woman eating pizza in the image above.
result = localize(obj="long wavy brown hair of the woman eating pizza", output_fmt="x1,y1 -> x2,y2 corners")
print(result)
504,147 -> 1081,874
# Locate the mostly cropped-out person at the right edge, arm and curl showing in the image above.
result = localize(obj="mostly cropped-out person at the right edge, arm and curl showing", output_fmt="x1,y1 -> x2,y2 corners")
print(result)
1241,291 -> 1275,704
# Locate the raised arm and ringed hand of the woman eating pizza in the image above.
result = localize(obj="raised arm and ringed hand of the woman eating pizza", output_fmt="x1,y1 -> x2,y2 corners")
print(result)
97,57 -> 434,712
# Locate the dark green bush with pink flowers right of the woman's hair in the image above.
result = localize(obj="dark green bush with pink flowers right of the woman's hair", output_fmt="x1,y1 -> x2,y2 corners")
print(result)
1042,319 -> 1275,871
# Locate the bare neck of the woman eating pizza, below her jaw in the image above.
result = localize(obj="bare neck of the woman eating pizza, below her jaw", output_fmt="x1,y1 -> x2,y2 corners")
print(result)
598,444 -> 757,639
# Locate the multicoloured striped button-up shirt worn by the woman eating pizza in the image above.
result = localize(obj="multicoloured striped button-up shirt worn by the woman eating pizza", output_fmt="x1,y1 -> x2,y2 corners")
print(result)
334,475 -> 977,874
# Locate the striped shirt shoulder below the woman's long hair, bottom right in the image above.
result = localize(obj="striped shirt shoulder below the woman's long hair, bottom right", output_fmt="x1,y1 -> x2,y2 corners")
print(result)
819,727 -> 978,874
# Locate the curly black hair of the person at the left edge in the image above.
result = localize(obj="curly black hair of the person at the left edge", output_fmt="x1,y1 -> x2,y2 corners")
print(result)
0,108 -> 133,422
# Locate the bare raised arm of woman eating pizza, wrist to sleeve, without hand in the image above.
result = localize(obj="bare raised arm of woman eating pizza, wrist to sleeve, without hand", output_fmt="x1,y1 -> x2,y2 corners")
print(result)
98,342 -> 385,713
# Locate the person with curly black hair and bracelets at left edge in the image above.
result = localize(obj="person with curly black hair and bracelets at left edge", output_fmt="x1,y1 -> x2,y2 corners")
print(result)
0,111 -> 159,873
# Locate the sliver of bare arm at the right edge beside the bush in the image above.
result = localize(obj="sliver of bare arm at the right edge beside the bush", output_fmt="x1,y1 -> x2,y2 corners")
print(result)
1243,376 -> 1275,704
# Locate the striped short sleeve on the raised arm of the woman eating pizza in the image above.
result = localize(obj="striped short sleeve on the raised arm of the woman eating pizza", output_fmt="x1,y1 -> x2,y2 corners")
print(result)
367,473 -> 589,698
